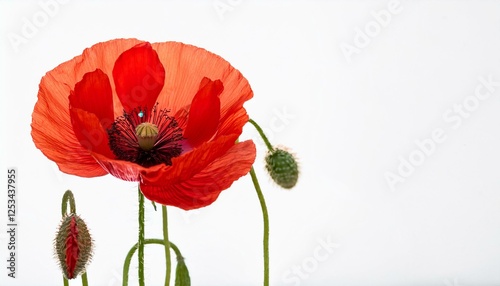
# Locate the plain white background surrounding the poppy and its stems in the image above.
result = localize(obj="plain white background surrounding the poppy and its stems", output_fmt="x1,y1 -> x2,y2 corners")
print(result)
0,0 -> 500,286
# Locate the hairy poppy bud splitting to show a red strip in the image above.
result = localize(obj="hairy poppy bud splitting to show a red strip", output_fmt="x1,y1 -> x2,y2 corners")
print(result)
54,214 -> 93,279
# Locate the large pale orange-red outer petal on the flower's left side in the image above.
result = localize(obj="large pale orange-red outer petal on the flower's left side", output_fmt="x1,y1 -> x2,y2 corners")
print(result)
31,39 -> 144,177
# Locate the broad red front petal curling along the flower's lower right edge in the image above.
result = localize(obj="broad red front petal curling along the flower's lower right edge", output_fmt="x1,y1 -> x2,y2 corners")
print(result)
141,141 -> 255,210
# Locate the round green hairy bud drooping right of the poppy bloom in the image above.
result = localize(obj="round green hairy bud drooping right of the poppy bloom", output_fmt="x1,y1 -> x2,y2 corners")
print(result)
266,148 -> 299,189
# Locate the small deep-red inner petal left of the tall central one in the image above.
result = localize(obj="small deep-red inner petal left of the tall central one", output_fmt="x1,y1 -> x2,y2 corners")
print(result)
69,69 -> 114,129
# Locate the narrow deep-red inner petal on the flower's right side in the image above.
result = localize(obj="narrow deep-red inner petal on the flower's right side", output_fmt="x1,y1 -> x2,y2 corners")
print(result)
184,78 -> 224,147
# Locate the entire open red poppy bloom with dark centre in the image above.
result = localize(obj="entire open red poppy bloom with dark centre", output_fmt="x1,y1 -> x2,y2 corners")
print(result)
31,39 -> 255,210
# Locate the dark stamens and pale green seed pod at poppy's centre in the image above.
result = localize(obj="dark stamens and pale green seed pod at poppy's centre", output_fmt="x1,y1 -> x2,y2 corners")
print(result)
108,105 -> 183,167
